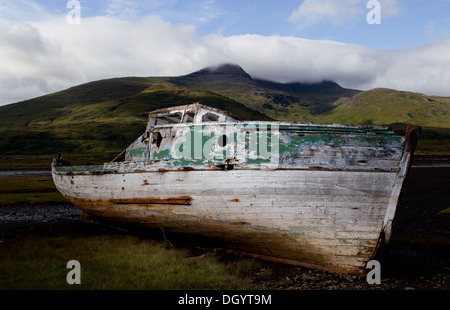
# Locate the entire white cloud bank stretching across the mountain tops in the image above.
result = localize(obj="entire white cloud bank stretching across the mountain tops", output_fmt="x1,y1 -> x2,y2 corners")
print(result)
0,16 -> 450,104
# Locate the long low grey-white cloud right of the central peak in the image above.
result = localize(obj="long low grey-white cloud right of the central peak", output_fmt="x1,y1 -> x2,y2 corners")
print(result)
214,35 -> 450,96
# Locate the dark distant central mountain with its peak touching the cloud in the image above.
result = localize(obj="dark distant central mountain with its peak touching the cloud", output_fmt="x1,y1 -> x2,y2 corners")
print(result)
170,64 -> 360,122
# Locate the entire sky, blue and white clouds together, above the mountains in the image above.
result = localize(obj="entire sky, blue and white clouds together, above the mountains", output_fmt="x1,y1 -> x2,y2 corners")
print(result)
0,0 -> 450,105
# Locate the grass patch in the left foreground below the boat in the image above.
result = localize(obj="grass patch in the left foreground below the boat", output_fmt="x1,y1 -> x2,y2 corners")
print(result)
0,234 -> 259,290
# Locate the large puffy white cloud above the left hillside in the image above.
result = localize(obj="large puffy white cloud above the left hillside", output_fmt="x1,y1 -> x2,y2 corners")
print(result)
0,16 -> 201,104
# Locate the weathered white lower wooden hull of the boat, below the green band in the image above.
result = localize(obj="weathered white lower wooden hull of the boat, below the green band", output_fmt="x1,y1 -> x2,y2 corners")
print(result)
53,167 -> 403,273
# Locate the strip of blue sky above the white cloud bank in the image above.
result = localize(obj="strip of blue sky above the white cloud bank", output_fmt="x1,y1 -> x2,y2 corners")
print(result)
10,0 -> 450,49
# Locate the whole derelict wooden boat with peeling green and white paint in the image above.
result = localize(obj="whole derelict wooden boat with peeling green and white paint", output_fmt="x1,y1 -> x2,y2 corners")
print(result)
52,104 -> 418,273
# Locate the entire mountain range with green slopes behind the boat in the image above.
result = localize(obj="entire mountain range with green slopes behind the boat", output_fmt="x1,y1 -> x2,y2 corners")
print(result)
0,64 -> 450,155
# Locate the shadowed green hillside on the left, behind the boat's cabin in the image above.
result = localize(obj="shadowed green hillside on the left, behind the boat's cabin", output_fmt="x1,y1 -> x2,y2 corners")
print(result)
0,78 -> 270,155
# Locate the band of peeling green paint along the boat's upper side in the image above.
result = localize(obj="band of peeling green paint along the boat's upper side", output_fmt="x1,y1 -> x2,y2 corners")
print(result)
121,122 -> 404,167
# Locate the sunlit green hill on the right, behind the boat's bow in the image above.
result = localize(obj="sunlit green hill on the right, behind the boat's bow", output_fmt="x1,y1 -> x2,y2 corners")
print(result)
318,88 -> 450,154
